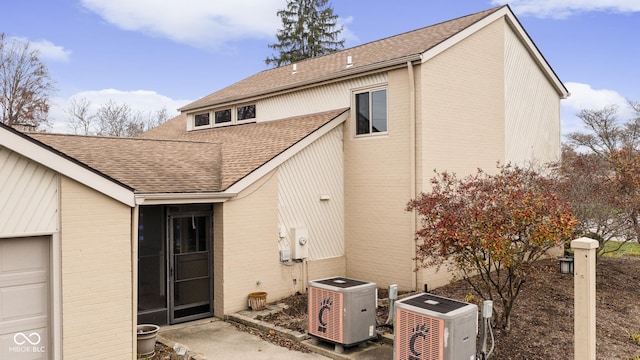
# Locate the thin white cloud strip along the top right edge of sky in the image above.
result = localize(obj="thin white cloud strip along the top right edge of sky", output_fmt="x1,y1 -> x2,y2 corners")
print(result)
491,0 -> 640,19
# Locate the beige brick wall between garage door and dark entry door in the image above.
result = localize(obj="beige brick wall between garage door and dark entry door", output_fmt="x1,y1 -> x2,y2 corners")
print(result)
61,177 -> 135,359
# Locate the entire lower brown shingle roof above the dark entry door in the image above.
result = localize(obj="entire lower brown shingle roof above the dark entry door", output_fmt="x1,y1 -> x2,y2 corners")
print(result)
28,109 -> 347,193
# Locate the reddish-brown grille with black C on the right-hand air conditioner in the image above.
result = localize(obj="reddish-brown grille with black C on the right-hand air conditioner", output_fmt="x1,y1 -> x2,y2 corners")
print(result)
395,308 -> 444,360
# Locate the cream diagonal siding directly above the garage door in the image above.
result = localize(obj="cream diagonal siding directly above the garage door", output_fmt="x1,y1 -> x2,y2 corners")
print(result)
0,147 -> 58,237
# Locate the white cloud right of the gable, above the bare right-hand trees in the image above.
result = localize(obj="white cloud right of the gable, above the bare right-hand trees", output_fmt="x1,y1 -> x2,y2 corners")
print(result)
560,82 -> 633,135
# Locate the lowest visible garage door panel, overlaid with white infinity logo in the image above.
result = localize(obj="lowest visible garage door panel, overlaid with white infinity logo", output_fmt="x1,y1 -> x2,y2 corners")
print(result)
0,328 -> 49,360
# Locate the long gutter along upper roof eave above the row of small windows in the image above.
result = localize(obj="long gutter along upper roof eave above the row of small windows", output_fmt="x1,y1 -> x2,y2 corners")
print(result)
178,54 -> 422,112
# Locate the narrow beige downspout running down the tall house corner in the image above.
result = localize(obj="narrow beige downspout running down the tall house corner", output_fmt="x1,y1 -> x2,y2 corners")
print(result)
407,61 -> 418,291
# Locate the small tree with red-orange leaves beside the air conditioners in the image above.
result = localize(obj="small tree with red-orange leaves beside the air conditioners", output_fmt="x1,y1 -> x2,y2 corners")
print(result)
407,164 -> 576,331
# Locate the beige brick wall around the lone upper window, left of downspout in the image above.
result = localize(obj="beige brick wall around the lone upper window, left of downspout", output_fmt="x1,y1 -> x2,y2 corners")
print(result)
344,68 -> 415,290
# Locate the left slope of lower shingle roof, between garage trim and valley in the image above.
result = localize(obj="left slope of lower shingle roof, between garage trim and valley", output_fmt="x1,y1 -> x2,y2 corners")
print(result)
28,133 -> 222,193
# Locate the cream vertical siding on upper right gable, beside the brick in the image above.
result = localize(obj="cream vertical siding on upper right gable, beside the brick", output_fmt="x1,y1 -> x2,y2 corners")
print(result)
504,24 -> 560,164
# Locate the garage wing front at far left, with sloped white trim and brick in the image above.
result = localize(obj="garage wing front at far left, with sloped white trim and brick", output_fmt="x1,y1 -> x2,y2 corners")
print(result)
0,124 -> 136,360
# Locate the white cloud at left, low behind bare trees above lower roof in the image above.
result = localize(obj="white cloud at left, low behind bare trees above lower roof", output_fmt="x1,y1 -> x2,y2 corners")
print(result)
49,89 -> 192,133
